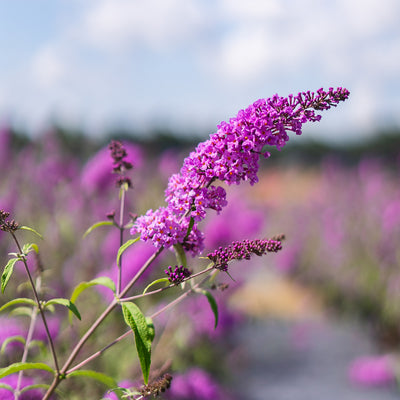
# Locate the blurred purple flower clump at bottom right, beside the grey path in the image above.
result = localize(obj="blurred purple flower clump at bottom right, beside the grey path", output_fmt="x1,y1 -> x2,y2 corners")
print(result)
348,355 -> 396,386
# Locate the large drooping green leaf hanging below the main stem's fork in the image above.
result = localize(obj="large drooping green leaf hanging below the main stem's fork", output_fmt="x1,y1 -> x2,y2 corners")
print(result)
122,303 -> 154,385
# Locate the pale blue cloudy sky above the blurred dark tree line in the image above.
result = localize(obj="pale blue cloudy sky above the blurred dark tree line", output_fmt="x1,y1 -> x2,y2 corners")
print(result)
0,0 -> 400,142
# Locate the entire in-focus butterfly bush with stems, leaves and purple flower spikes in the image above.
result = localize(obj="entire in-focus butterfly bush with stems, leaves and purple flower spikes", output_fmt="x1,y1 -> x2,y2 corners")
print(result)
0,88 -> 349,400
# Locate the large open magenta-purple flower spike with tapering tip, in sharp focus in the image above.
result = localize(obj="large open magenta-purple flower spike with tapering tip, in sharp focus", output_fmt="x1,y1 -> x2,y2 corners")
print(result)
131,87 -> 349,255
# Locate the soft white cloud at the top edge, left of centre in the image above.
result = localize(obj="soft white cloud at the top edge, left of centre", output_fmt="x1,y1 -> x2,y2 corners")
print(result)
82,0 -> 206,50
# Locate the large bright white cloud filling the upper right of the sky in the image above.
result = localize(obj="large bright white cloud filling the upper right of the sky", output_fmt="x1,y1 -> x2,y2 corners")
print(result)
203,0 -> 400,86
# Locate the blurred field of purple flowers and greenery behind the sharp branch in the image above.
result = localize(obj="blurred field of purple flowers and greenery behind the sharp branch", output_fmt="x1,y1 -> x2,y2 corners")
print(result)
0,124 -> 400,400
